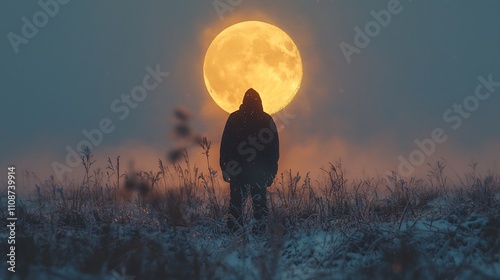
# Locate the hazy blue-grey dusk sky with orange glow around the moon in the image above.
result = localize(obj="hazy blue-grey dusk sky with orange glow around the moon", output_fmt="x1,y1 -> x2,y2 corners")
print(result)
0,0 -> 500,189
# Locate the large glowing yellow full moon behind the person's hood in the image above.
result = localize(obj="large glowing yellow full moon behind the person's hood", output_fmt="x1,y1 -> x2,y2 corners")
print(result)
203,21 -> 302,114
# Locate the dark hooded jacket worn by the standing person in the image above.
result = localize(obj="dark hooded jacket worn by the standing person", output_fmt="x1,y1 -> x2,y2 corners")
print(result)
220,89 -> 279,186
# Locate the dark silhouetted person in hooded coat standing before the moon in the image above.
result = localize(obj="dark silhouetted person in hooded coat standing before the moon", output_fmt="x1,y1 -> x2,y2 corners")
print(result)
220,88 -> 279,233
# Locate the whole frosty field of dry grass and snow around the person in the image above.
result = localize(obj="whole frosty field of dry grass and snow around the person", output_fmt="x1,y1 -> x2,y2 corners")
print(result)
0,161 -> 500,279
